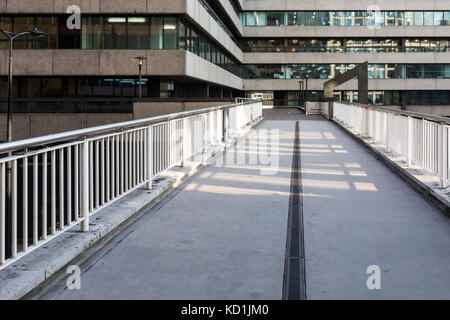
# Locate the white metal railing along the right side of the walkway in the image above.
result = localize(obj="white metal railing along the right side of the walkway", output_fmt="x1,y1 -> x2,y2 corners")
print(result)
333,102 -> 450,188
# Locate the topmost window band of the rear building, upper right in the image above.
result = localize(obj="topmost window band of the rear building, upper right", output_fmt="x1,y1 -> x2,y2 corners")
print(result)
239,11 -> 450,27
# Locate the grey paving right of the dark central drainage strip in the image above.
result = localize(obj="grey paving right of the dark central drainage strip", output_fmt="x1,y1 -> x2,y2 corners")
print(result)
300,117 -> 450,299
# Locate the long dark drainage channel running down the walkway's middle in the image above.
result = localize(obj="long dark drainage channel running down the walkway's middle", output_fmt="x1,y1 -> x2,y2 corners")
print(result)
283,121 -> 306,300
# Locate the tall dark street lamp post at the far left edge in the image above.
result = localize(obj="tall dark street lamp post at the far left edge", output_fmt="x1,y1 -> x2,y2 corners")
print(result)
0,29 -> 45,256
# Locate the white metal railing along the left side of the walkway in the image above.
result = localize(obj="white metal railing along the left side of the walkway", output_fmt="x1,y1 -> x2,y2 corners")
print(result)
0,101 -> 262,268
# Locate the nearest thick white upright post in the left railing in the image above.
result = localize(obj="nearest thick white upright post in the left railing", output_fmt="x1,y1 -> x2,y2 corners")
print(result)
80,140 -> 89,232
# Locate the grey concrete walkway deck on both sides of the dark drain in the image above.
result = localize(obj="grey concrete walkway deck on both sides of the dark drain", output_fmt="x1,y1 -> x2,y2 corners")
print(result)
44,109 -> 450,299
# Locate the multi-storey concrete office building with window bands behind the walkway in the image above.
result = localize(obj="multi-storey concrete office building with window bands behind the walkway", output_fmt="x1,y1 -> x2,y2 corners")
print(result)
0,0 -> 450,139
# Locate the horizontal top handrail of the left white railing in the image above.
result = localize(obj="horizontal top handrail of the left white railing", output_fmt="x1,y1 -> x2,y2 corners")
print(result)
0,101 -> 255,155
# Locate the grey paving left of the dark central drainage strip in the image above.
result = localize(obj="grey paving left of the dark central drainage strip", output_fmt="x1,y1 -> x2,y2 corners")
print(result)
45,115 -> 295,299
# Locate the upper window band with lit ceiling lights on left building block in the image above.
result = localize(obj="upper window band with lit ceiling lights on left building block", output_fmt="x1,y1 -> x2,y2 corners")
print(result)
0,16 -> 238,74
